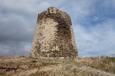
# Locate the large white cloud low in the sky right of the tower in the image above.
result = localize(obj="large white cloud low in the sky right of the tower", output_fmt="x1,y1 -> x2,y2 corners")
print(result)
74,19 -> 115,56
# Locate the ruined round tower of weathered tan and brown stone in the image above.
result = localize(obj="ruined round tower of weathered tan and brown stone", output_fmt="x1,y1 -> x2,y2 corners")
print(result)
32,7 -> 77,57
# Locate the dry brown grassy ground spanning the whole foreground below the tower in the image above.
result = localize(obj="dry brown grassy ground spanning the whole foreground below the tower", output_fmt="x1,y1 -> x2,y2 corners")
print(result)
0,57 -> 115,76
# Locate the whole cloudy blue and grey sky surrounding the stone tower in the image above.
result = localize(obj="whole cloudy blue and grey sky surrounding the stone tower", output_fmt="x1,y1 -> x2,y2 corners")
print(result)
0,0 -> 115,56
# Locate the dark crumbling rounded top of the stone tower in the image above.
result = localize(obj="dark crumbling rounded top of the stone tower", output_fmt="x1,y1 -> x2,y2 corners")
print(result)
38,7 -> 72,25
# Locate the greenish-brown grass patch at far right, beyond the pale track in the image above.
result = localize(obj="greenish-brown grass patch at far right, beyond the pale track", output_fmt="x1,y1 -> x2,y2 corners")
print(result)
79,57 -> 115,73
